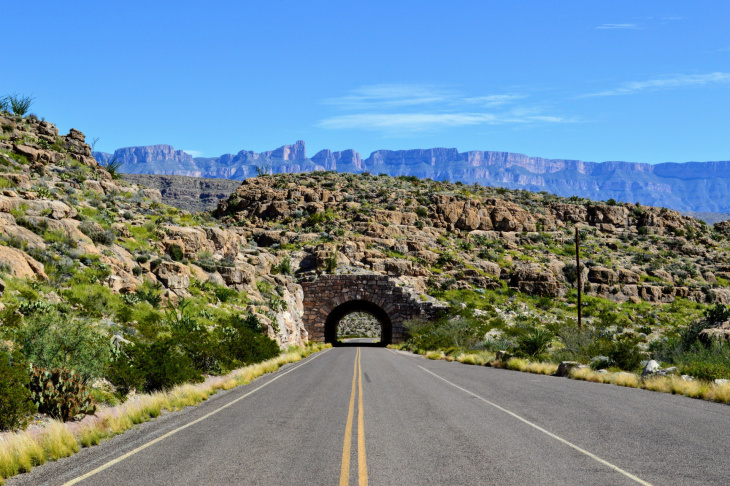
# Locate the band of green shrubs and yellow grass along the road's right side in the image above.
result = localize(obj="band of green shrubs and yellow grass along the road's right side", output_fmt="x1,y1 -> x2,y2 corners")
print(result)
391,289 -> 730,403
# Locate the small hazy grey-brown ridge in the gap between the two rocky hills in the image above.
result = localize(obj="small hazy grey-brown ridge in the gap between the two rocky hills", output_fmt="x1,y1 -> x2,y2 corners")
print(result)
122,174 -> 241,213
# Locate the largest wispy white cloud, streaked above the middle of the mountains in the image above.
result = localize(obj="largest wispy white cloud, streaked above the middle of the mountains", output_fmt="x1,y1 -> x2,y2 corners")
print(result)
317,84 -> 573,134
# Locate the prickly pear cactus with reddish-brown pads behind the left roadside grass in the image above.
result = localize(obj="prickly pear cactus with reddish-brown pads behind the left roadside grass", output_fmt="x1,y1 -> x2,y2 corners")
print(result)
30,366 -> 96,422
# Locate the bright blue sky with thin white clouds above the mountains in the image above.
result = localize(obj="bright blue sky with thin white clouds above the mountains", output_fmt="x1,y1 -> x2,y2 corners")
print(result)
0,0 -> 730,163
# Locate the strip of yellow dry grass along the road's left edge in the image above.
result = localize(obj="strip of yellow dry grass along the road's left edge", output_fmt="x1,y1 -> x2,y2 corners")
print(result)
0,344 -> 331,485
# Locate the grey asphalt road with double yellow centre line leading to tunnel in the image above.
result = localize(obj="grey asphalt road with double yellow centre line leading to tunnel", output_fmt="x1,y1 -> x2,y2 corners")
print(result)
7,347 -> 730,485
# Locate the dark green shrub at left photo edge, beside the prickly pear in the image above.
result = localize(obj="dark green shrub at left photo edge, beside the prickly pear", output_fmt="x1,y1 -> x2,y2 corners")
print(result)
0,348 -> 36,430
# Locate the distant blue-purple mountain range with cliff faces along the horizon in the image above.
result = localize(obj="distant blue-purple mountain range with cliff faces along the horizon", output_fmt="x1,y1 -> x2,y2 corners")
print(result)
93,140 -> 730,215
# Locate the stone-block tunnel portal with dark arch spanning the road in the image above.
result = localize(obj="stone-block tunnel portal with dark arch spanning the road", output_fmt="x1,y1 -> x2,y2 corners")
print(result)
301,275 -> 440,346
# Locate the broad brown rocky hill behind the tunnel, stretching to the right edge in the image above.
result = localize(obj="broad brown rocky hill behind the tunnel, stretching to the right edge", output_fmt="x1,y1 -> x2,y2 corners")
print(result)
215,172 -> 730,303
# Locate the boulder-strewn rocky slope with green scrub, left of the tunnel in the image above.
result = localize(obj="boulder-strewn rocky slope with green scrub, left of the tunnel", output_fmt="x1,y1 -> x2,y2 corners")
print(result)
0,113 -> 307,347
